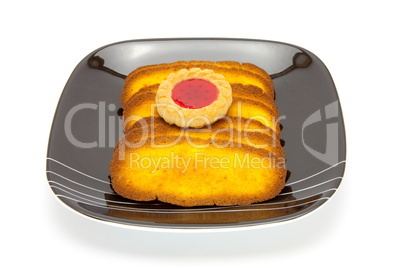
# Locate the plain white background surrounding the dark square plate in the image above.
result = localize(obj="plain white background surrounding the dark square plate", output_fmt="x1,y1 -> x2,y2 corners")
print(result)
0,0 -> 402,267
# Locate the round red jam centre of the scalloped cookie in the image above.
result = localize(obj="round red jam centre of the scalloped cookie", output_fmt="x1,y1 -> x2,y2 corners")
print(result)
172,79 -> 219,109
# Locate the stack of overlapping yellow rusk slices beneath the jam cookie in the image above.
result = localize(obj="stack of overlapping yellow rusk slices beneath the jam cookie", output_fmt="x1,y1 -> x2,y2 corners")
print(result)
110,61 -> 287,207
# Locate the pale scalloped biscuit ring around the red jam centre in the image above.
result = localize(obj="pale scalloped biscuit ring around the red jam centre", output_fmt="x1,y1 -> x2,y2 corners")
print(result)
155,68 -> 232,128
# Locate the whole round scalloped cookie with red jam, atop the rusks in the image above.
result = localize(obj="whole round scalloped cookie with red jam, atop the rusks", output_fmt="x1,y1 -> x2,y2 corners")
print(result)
155,68 -> 232,128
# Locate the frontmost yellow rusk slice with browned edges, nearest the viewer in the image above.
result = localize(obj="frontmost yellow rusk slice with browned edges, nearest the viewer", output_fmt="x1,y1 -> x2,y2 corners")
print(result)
110,136 -> 286,207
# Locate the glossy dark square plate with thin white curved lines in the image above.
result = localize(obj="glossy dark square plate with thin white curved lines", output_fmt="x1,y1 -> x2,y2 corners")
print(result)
47,38 -> 346,229
